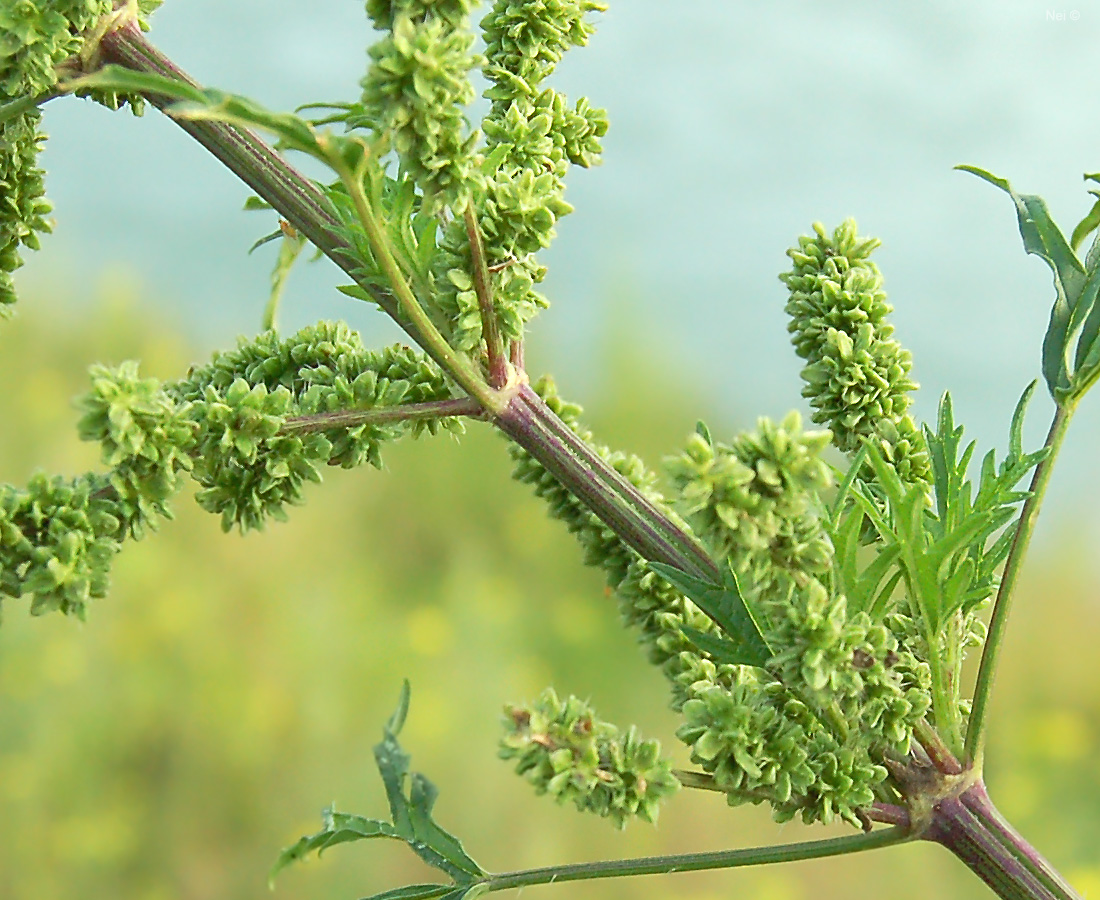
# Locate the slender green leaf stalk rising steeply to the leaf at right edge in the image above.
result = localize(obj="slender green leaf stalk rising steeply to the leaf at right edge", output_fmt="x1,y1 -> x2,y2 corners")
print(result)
965,400 -> 1076,766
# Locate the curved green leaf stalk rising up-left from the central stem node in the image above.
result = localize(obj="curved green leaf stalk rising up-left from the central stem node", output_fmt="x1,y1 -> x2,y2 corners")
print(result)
330,153 -> 507,413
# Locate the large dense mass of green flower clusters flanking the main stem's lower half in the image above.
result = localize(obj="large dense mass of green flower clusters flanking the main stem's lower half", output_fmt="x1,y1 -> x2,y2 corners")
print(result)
512,382 -> 930,824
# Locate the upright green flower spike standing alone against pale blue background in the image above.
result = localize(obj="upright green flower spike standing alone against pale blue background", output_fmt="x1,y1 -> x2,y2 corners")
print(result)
780,219 -> 931,483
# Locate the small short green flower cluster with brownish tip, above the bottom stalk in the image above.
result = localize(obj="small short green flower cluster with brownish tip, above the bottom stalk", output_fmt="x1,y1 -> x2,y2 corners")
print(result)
499,688 -> 680,828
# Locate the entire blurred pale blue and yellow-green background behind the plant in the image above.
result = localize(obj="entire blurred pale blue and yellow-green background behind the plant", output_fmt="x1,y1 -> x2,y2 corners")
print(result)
0,0 -> 1100,900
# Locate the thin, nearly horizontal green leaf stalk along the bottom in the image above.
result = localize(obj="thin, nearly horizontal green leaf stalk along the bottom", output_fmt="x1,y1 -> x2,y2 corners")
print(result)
485,826 -> 912,891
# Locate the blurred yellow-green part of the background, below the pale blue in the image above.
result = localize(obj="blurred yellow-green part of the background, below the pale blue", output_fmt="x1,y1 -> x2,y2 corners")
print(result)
0,282 -> 1100,900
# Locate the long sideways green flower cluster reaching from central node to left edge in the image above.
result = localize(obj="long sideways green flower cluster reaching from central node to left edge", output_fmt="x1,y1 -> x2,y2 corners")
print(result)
0,322 -> 461,615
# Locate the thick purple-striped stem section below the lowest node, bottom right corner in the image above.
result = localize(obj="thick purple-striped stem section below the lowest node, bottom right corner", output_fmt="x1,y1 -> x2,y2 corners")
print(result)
922,781 -> 1080,900
